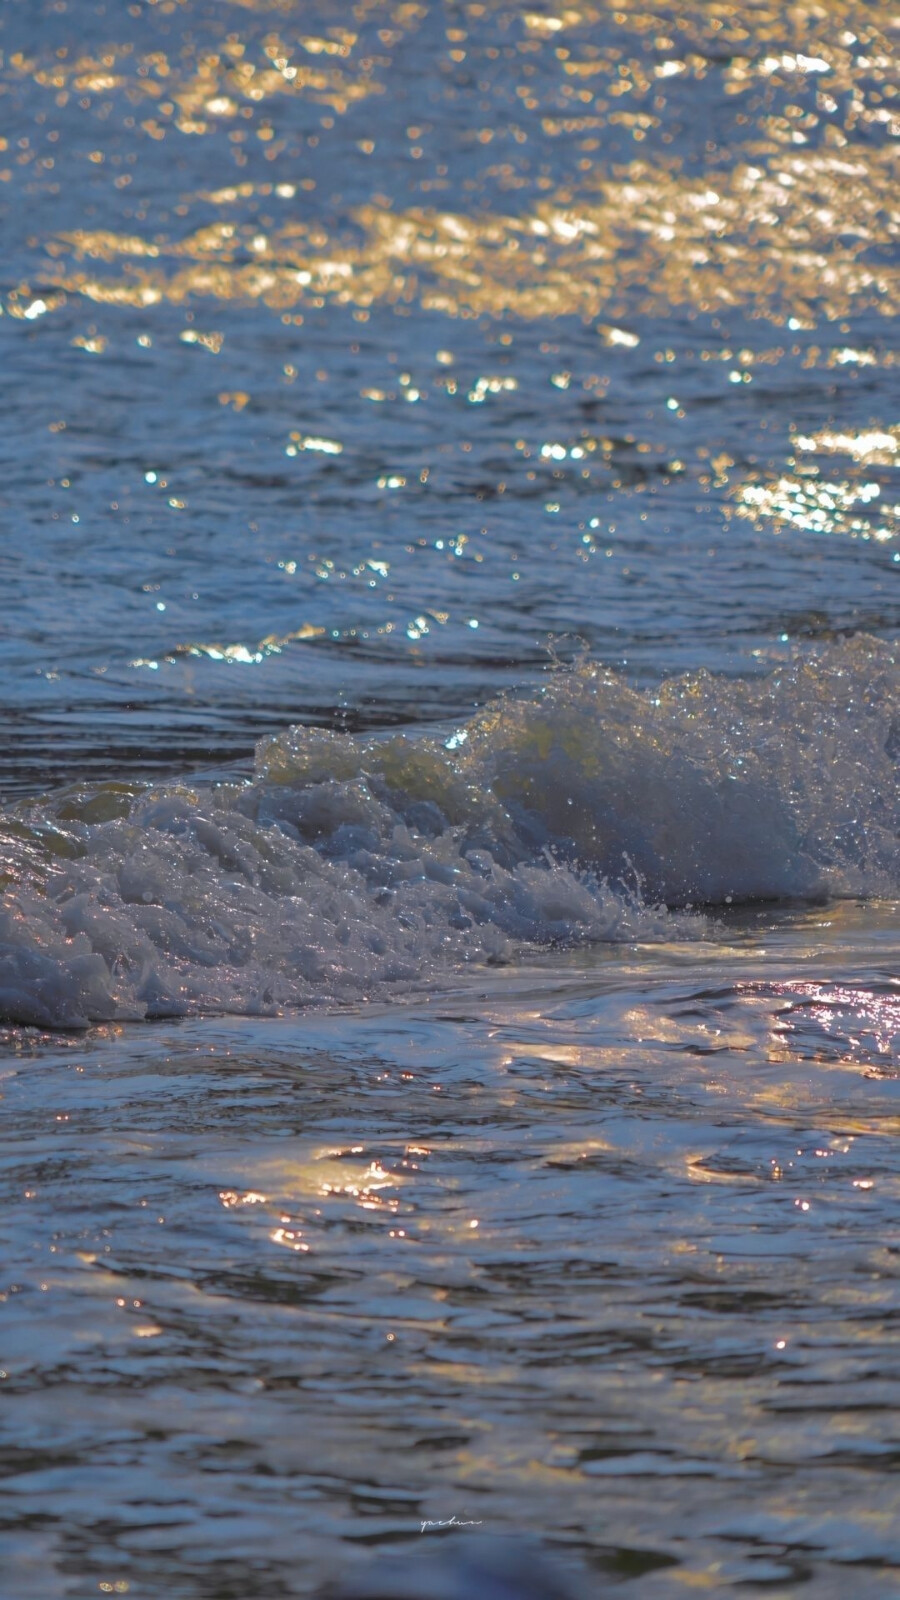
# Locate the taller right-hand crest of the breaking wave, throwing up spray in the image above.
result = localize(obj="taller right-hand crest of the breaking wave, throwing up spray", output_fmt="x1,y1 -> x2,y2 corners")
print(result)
466,637 -> 900,906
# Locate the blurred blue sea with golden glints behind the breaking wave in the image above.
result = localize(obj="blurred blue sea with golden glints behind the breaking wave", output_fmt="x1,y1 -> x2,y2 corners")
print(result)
0,0 -> 900,787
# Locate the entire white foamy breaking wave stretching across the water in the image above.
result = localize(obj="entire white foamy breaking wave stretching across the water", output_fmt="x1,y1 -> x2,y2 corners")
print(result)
0,638 -> 900,1027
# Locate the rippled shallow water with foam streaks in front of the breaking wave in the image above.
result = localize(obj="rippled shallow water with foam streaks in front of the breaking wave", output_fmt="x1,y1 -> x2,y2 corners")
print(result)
2,906 -> 900,1597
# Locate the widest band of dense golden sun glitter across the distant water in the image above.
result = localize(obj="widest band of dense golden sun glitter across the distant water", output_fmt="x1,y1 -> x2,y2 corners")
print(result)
28,149 -> 900,328
